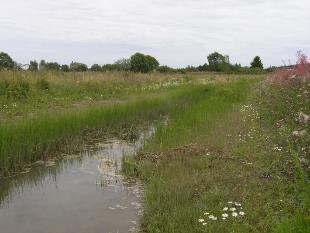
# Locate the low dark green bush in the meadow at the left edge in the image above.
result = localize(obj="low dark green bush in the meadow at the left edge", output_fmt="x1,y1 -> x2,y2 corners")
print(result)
0,80 -> 30,100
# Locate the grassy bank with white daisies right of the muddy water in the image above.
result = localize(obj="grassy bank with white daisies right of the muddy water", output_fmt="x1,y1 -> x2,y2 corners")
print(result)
124,80 -> 310,233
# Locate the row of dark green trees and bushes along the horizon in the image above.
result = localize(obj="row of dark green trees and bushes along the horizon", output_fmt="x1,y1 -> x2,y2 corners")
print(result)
0,52 -> 272,73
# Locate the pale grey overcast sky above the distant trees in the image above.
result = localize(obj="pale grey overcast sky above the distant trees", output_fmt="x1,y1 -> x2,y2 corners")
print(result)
0,0 -> 310,67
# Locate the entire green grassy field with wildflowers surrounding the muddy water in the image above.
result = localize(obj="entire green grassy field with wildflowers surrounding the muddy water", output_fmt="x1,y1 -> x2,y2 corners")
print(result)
0,72 -> 310,233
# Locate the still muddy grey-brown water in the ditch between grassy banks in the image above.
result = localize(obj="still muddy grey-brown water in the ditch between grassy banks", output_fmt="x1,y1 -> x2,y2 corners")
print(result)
0,128 -> 154,233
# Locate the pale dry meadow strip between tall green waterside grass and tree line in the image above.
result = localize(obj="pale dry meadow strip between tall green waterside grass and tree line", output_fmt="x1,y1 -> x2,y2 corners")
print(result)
0,71 -> 264,122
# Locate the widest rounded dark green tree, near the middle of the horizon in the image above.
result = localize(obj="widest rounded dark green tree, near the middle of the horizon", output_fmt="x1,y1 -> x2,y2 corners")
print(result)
130,53 -> 159,73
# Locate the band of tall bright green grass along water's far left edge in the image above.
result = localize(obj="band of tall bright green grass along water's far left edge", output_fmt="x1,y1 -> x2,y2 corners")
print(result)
0,86 -> 206,176
